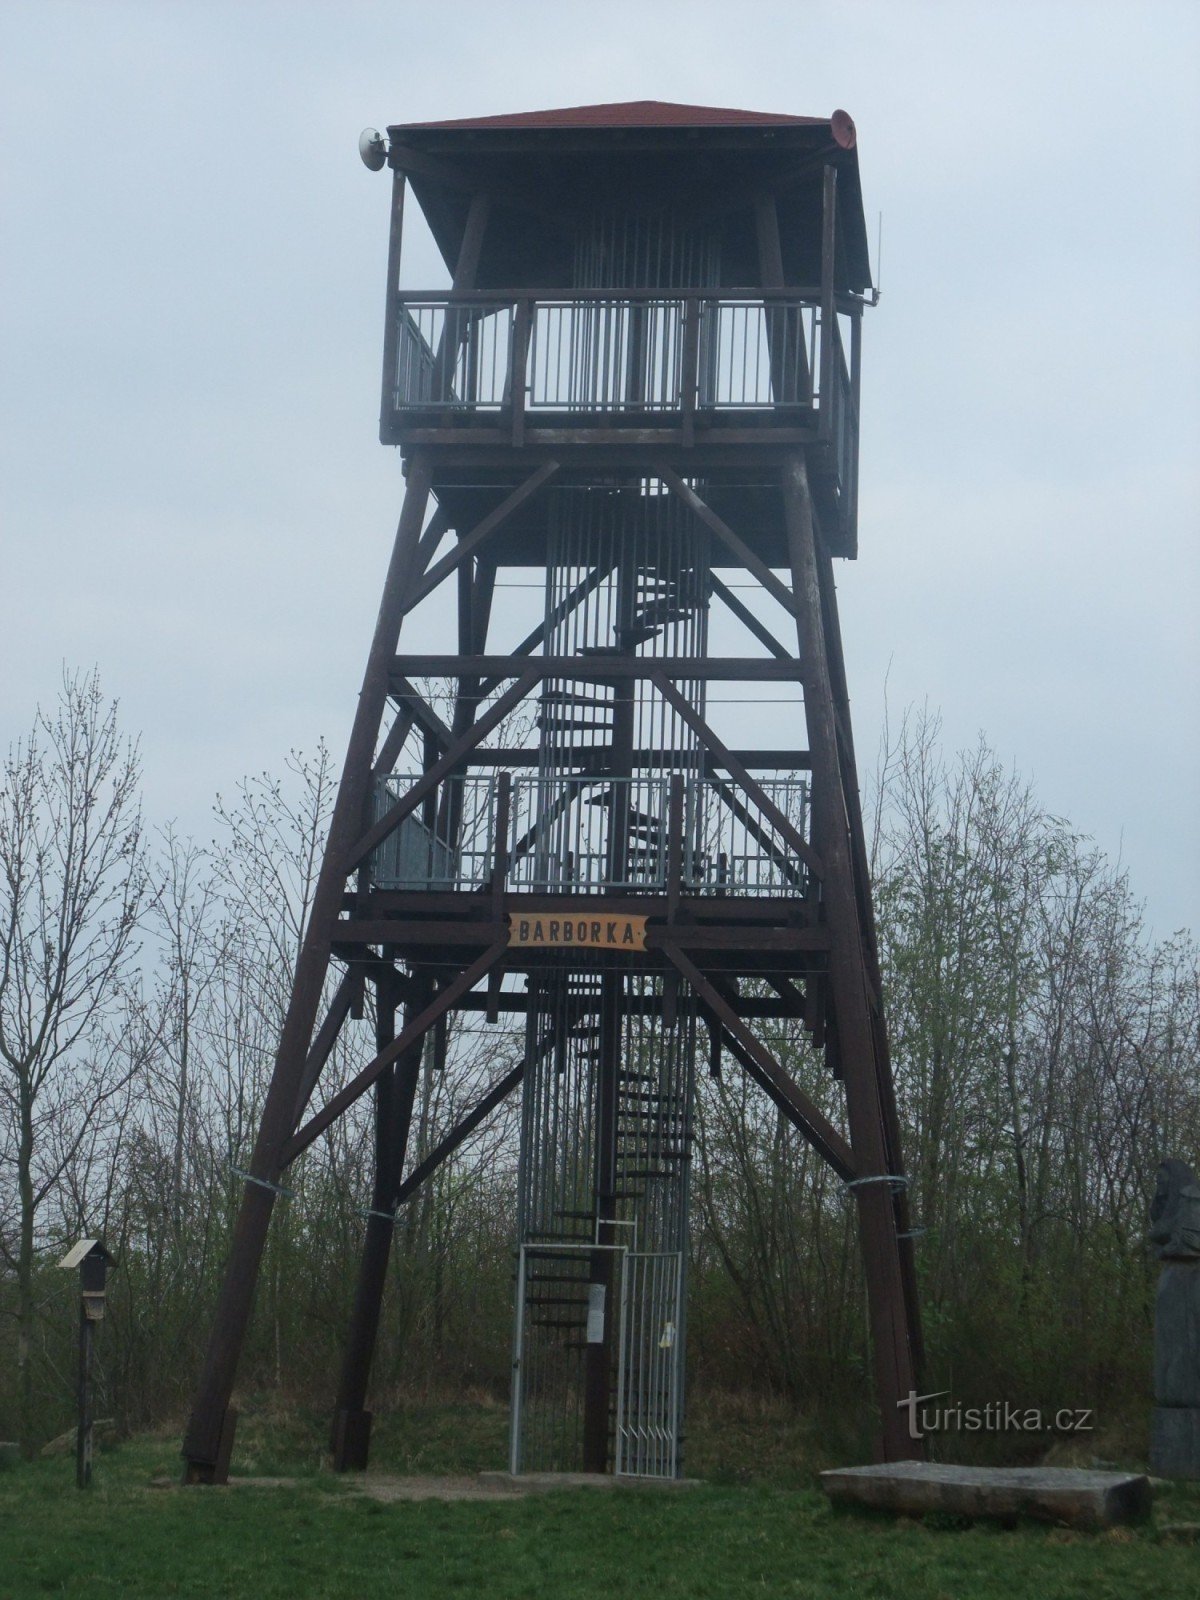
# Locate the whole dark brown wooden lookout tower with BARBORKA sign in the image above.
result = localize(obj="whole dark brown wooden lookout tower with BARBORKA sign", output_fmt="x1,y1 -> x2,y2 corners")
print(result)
184,101 -> 920,1482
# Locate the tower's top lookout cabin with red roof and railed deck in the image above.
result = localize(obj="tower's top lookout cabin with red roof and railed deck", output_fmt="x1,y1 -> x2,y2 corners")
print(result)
379,101 -> 874,565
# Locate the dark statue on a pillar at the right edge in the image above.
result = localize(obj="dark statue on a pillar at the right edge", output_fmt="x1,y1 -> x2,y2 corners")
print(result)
1150,1162 -> 1200,1478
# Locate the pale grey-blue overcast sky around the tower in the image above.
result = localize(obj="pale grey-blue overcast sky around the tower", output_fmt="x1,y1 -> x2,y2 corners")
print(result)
0,0 -> 1200,933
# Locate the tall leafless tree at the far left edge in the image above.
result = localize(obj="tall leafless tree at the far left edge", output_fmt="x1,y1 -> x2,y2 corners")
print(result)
0,672 -> 149,1451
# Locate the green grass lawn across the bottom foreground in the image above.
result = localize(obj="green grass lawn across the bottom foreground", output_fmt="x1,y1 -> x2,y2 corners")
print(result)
0,1405 -> 1200,1600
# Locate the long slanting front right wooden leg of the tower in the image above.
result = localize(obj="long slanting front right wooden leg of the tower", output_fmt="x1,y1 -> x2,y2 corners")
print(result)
782,454 -> 922,1461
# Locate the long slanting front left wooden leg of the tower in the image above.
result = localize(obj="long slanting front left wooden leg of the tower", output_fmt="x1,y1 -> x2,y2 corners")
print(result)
182,456 -> 432,1483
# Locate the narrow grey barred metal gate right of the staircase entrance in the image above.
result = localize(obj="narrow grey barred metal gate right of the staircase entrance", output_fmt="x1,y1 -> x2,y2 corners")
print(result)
613,1250 -> 683,1478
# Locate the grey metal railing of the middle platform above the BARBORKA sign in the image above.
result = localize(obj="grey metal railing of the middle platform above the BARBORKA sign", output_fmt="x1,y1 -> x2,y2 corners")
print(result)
371,774 -> 808,896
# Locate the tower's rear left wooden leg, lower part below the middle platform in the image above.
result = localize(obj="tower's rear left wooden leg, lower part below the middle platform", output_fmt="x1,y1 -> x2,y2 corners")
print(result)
331,979 -> 429,1472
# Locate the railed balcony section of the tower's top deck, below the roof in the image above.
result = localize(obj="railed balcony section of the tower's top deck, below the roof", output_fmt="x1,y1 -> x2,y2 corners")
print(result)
381,286 -> 859,547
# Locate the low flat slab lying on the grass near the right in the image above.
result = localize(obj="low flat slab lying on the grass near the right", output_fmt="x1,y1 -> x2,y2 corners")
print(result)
821,1461 -> 1150,1528
